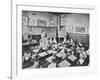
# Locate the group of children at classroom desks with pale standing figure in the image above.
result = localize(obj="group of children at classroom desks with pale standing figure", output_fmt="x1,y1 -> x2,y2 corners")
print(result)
22,32 -> 89,68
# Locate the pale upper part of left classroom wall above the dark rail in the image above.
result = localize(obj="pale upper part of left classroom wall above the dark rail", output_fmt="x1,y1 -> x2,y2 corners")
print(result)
22,11 -> 57,27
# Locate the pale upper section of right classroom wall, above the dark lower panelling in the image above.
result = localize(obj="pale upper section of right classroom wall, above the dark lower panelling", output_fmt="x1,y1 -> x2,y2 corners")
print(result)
65,13 -> 89,34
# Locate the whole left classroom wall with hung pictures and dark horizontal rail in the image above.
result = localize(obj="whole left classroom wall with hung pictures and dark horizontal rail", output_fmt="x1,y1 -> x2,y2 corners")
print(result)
22,11 -> 57,37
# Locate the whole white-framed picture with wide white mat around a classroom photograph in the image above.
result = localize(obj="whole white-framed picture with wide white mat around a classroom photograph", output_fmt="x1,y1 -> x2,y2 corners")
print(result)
11,1 -> 96,80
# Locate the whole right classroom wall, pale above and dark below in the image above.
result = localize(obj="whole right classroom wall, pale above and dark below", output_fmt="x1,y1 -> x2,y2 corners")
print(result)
58,13 -> 89,43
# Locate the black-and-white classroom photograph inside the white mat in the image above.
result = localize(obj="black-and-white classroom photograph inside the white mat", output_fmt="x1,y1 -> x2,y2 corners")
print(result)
22,10 -> 90,69
